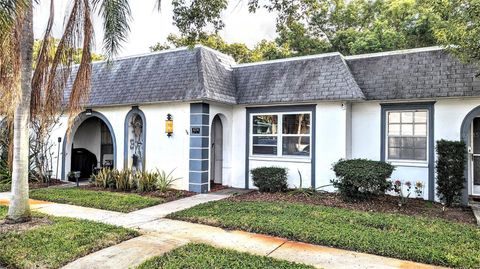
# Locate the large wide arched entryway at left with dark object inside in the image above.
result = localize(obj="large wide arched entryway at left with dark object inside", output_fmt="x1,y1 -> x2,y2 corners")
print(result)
62,110 -> 116,180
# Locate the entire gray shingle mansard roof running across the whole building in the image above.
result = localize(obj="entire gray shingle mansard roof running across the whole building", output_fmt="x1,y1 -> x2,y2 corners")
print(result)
65,46 -> 480,107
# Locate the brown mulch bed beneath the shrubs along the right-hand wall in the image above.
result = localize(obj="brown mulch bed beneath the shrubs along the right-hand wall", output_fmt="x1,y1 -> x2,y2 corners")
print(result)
228,191 -> 476,224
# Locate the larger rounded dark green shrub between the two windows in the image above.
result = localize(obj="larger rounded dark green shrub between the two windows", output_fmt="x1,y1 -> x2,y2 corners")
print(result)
331,159 -> 395,200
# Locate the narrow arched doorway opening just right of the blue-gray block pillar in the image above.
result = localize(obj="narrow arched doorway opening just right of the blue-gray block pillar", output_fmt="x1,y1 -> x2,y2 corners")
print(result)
210,115 -> 224,190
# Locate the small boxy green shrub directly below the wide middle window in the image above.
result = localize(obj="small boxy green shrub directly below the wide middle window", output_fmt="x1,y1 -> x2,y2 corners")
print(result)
251,167 -> 287,192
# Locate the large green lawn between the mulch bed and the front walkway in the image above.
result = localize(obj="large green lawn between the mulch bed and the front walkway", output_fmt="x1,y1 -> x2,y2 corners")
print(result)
168,201 -> 480,268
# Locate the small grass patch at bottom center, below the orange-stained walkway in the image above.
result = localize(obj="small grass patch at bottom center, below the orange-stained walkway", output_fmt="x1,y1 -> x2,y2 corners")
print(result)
138,244 -> 313,269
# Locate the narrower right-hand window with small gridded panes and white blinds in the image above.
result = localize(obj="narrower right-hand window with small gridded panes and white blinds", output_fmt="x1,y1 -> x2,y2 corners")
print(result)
386,110 -> 428,161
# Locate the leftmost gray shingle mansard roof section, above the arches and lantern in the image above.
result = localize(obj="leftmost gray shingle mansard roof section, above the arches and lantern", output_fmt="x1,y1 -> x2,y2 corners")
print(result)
64,47 -> 235,106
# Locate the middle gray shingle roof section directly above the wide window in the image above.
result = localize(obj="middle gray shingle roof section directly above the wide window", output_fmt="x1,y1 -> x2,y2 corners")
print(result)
234,53 -> 364,104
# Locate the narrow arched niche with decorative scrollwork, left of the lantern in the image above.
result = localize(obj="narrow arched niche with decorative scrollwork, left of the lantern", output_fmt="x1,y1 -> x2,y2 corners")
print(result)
124,107 -> 146,172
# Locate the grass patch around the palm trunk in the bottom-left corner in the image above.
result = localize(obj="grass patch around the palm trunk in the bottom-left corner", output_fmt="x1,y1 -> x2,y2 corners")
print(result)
0,206 -> 138,268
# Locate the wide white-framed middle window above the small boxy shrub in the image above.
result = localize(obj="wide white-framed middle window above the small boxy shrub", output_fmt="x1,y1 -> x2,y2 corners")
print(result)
251,113 -> 311,157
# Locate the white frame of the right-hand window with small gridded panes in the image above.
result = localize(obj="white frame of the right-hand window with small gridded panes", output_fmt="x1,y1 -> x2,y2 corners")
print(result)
383,108 -> 431,163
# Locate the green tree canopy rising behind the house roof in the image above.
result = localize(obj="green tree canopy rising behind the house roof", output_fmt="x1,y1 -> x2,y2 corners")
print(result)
156,0 -> 480,68
